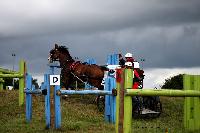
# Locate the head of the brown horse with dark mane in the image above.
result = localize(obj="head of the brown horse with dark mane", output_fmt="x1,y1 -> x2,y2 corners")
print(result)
48,44 -> 72,62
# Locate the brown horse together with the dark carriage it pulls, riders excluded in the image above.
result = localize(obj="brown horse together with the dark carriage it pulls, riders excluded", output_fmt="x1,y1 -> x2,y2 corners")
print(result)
49,44 -> 162,117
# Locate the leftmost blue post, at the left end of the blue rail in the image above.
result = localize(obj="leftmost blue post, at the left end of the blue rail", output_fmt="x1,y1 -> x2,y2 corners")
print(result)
26,74 -> 32,123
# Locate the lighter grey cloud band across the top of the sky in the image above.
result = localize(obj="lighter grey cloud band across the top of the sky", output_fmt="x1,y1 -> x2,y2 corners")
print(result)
0,0 -> 200,36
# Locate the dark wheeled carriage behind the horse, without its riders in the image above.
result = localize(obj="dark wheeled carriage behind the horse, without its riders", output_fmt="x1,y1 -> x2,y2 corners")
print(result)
97,65 -> 162,118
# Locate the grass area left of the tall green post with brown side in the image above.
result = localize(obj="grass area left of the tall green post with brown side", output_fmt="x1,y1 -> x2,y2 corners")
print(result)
0,91 -> 115,133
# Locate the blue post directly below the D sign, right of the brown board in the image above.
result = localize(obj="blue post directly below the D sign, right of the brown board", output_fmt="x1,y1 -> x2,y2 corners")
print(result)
54,85 -> 61,129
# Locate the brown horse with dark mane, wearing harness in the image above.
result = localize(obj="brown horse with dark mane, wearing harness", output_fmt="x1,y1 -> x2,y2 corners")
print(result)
49,44 -> 107,90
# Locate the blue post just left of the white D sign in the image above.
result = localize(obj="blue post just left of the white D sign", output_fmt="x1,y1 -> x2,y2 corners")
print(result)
44,74 -> 51,128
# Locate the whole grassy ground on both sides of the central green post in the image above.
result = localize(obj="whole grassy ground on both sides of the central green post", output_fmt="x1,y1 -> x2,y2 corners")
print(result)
0,91 -> 195,133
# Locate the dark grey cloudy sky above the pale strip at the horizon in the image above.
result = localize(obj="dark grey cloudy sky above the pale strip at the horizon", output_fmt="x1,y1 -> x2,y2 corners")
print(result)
0,0 -> 200,86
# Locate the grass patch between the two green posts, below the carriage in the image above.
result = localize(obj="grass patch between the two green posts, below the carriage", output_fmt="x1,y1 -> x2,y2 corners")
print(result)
133,97 -> 185,133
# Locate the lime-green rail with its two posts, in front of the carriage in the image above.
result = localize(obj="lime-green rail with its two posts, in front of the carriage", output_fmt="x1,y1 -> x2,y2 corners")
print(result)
115,69 -> 200,133
